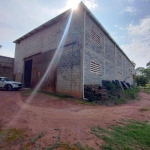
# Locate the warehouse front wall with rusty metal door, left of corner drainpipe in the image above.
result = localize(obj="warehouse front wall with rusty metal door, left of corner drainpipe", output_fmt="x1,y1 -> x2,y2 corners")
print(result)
14,11 -> 83,97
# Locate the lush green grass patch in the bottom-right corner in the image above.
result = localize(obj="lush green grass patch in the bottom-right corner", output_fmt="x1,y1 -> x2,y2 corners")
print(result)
91,120 -> 150,150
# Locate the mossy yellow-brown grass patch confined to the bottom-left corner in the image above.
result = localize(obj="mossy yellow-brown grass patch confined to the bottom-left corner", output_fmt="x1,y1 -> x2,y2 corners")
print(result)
0,124 -> 45,150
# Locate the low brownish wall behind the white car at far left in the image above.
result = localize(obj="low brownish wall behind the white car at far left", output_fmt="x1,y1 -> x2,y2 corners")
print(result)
0,56 -> 14,79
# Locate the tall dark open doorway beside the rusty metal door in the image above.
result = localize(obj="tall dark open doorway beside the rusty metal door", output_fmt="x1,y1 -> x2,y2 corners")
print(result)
24,59 -> 32,88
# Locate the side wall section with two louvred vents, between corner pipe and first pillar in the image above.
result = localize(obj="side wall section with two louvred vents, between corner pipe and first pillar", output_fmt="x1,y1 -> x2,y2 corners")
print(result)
84,15 -> 105,85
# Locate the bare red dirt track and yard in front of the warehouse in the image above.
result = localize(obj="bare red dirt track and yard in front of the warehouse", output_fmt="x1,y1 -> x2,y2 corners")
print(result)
0,90 -> 150,148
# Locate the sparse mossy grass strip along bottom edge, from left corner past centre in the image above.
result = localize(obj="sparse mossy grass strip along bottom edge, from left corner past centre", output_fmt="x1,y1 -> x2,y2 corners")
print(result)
0,124 -> 94,150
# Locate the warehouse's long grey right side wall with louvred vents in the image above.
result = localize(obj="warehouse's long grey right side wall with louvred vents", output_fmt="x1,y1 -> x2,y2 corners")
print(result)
84,14 -> 134,85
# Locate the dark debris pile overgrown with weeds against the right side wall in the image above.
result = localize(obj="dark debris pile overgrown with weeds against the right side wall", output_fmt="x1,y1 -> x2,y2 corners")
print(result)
84,81 -> 139,105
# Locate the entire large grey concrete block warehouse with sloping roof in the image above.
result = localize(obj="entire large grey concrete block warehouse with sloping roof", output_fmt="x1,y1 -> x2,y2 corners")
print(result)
14,2 -> 135,98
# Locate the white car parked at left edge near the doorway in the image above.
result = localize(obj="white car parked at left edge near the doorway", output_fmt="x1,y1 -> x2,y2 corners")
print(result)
0,77 -> 22,91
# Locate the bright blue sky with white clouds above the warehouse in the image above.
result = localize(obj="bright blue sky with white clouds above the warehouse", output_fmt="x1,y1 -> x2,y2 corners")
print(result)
0,0 -> 150,67
